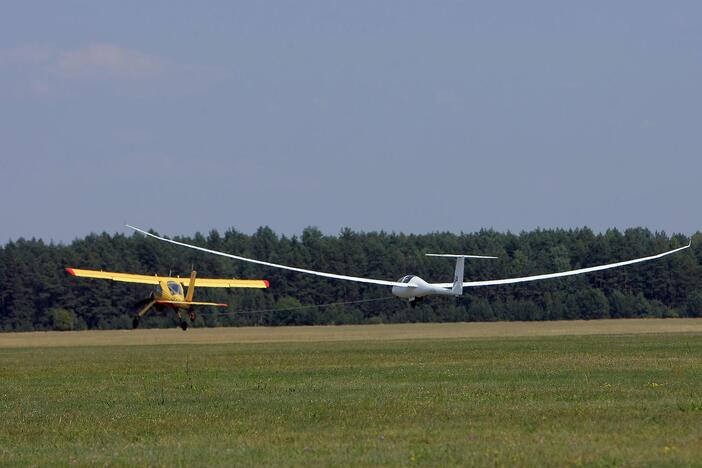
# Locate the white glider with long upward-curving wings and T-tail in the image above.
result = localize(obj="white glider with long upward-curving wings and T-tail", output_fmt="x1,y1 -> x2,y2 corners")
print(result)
126,224 -> 692,302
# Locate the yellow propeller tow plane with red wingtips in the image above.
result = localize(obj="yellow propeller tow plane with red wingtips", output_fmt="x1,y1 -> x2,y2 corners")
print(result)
66,268 -> 270,330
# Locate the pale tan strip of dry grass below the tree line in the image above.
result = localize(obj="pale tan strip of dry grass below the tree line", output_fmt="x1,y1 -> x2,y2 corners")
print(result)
0,318 -> 702,348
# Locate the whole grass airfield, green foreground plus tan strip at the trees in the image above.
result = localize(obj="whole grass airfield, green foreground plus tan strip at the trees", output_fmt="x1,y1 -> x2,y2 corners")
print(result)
0,319 -> 702,466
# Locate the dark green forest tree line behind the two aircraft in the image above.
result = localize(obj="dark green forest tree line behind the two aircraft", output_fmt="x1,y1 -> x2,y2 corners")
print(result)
0,227 -> 702,331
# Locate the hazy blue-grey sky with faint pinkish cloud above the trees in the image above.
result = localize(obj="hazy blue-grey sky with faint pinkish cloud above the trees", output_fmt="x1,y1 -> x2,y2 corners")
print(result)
0,0 -> 702,243
